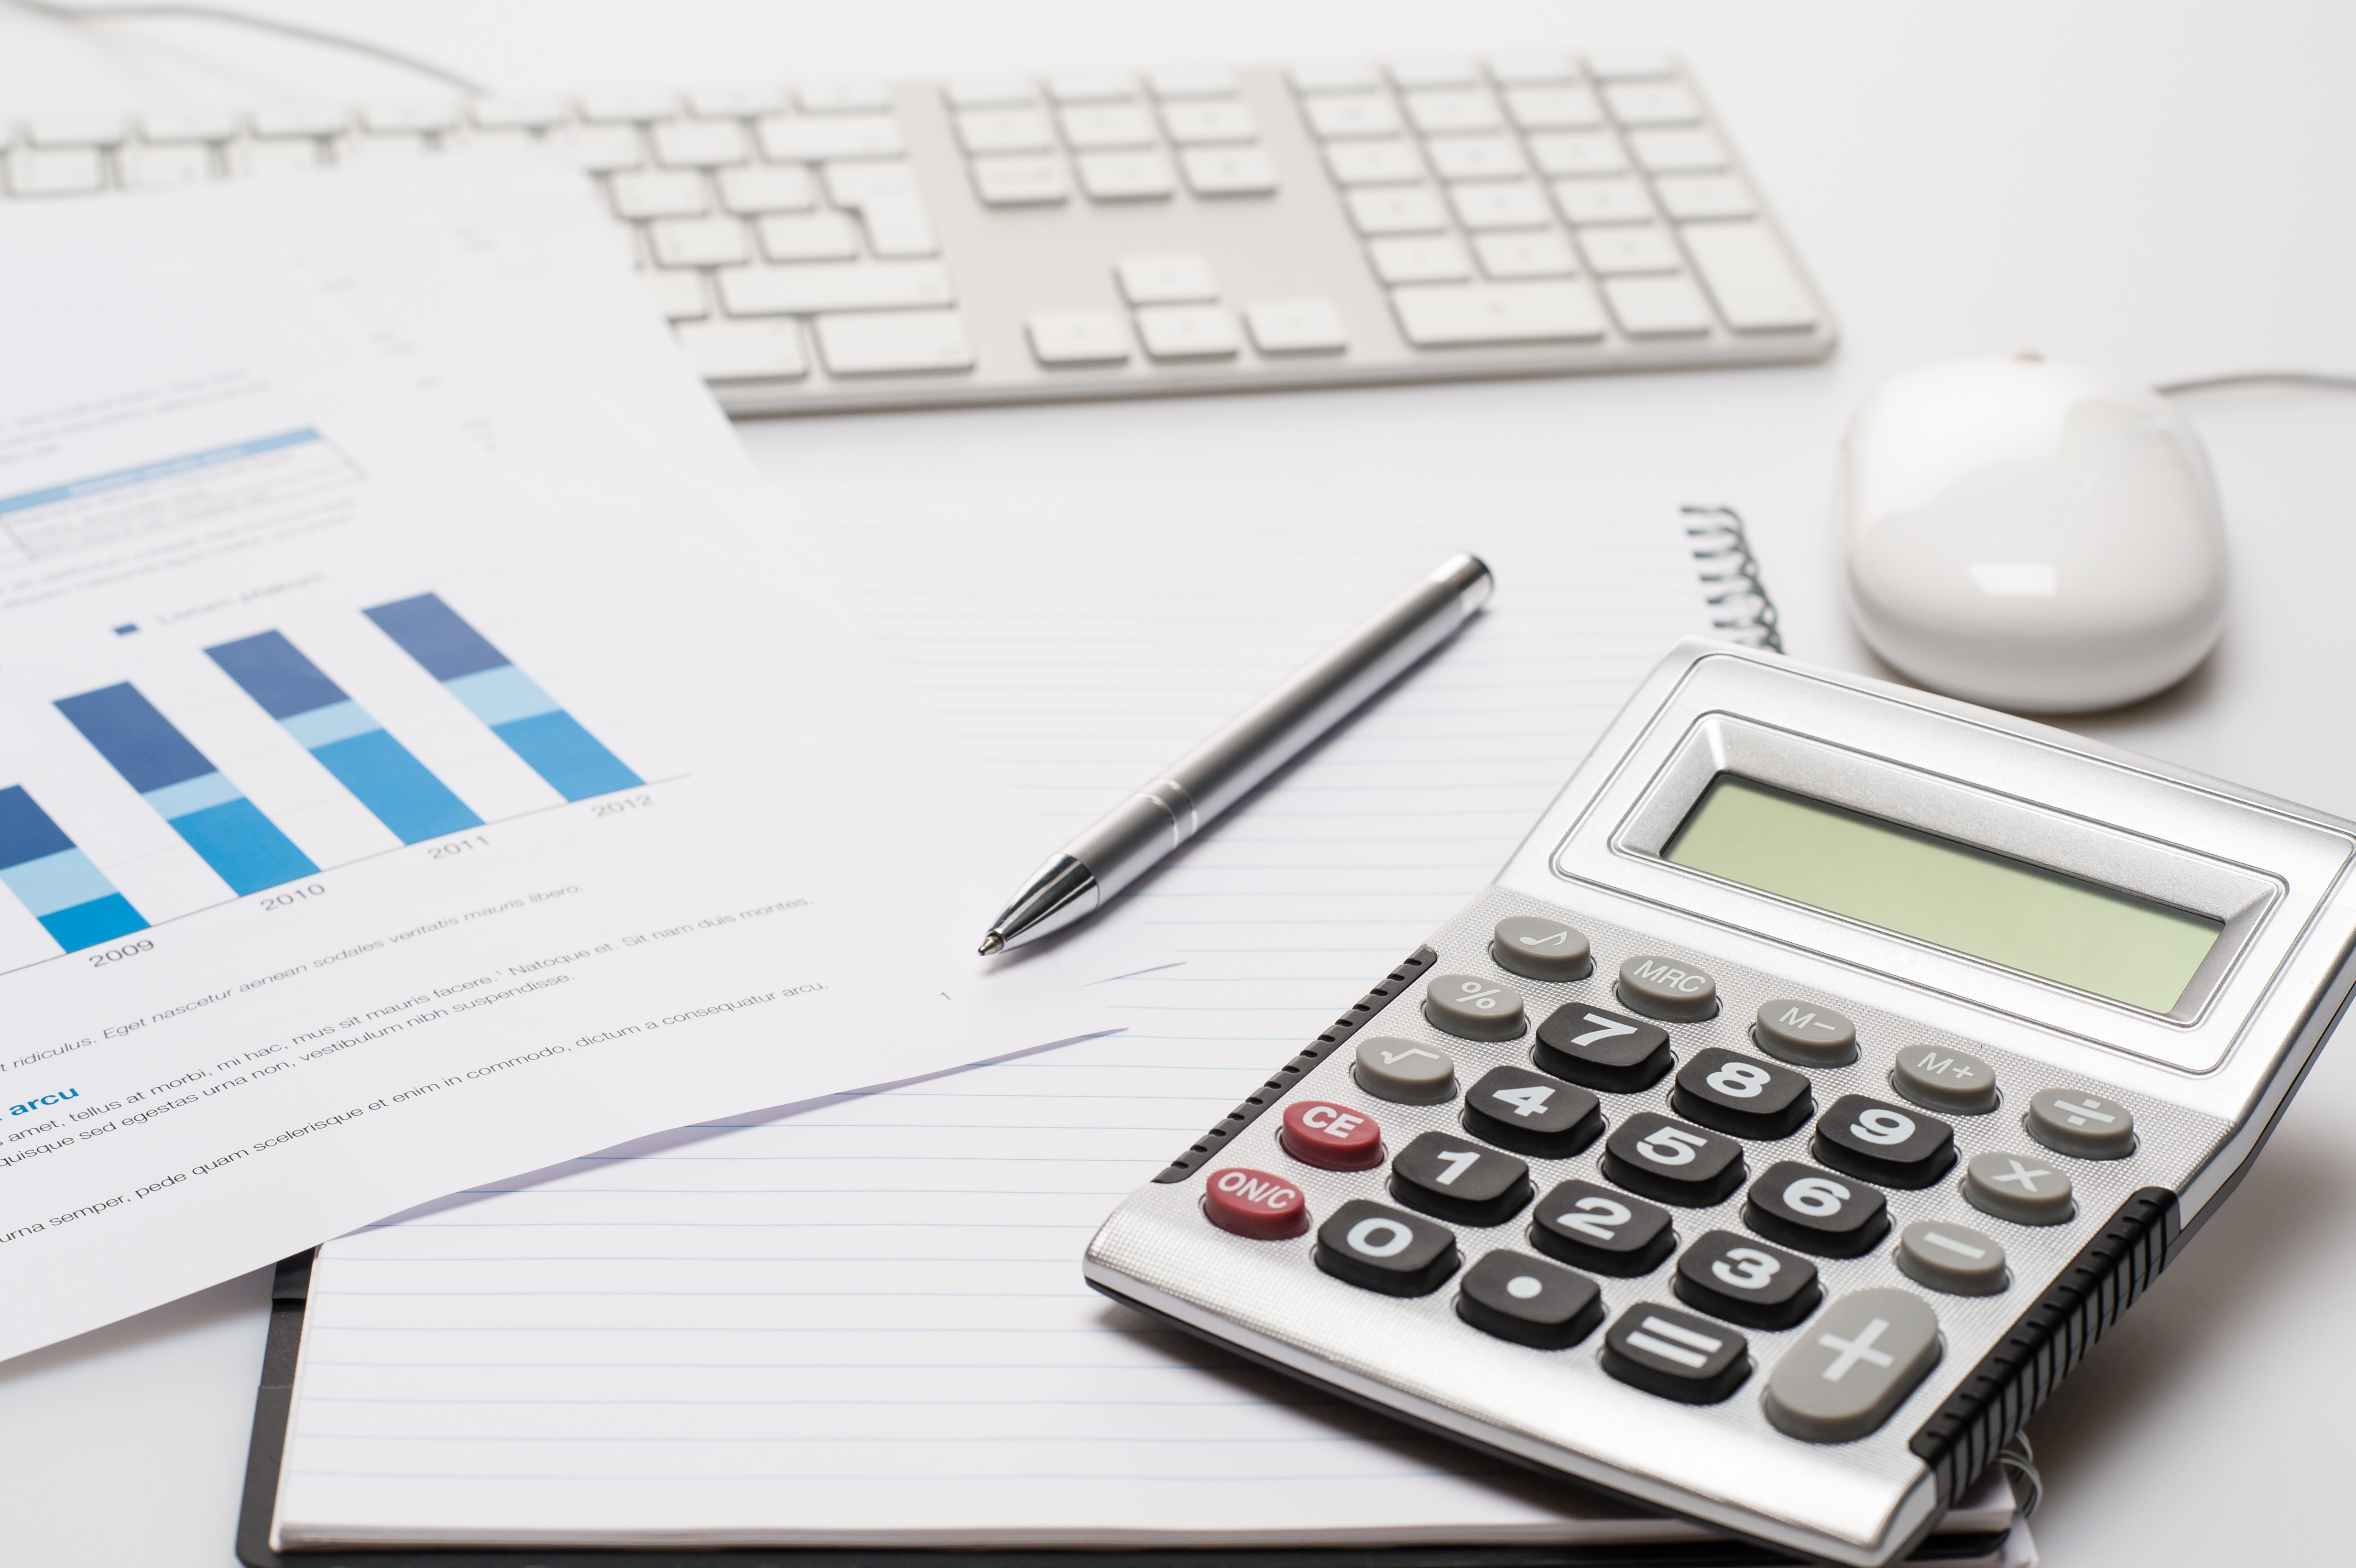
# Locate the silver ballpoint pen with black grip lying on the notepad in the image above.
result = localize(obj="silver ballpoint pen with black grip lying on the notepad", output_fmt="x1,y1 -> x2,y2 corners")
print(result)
982,555 -> 1496,956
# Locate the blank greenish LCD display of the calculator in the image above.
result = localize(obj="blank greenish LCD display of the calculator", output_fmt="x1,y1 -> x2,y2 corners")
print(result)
1661,772 -> 2224,1013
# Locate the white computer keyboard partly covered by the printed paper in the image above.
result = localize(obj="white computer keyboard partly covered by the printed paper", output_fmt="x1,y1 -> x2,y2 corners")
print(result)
0,54 -> 1833,414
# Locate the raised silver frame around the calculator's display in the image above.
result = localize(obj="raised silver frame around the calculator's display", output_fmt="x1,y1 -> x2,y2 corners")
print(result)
1548,654 -> 2356,1074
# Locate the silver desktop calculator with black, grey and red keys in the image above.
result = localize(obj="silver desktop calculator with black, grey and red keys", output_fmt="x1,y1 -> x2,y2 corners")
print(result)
1086,641 -> 2356,1568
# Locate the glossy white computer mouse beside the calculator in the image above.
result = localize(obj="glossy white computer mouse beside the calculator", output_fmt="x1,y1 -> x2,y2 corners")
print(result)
1835,356 -> 2226,713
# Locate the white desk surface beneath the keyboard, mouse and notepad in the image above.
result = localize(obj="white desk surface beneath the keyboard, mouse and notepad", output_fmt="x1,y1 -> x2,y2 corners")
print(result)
0,0 -> 2356,1568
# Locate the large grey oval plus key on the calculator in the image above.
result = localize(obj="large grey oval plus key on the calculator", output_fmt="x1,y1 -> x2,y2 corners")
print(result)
1760,1290 -> 1942,1443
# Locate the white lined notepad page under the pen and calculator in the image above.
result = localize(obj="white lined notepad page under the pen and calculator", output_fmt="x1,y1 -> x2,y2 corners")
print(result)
278,487 -> 1837,1545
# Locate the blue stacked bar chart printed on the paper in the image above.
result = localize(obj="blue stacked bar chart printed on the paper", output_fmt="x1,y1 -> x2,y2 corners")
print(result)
0,593 -> 643,970
